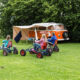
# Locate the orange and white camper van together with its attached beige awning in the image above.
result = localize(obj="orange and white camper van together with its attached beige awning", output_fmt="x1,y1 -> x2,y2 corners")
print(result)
13,23 -> 69,41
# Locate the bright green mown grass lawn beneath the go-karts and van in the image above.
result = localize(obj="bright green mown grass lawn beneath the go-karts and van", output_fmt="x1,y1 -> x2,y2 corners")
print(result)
0,40 -> 80,80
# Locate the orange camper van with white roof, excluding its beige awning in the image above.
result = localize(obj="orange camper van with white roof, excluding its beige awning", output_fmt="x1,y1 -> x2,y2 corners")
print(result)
28,23 -> 69,41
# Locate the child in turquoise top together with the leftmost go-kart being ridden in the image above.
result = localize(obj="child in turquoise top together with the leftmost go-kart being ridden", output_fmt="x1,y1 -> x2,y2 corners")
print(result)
0,35 -> 18,56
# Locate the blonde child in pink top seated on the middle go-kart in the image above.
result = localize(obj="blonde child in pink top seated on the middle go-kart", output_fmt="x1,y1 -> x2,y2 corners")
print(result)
34,34 -> 47,50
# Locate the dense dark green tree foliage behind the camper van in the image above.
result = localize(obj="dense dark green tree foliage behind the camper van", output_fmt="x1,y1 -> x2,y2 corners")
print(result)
0,0 -> 80,41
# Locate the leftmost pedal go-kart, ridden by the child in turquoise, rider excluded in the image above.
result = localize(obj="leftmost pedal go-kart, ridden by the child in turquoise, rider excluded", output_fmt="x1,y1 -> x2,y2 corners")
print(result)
0,41 -> 18,56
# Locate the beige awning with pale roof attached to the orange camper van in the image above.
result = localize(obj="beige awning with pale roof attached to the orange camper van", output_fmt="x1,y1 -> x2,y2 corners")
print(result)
13,23 -> 63,40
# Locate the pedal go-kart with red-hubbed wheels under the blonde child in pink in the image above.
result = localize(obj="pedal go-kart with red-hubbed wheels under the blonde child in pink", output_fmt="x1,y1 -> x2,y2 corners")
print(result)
20,42 -> 52,58
